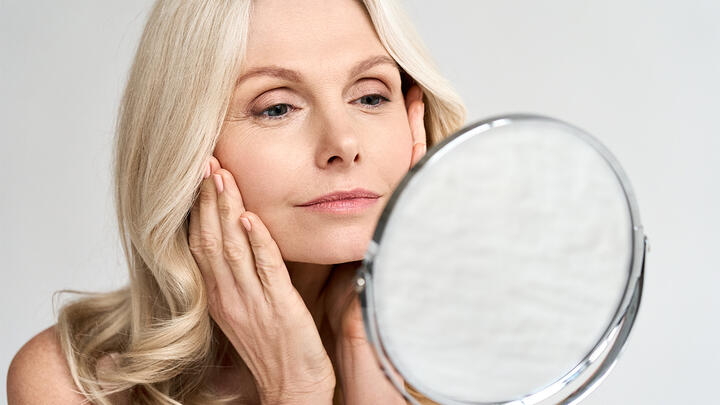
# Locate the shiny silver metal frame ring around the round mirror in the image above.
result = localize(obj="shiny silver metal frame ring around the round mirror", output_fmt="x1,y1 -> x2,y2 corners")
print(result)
354,114 -> 649,405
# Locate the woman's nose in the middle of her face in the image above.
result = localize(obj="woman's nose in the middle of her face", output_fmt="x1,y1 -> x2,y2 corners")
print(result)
317,104 -> 361,169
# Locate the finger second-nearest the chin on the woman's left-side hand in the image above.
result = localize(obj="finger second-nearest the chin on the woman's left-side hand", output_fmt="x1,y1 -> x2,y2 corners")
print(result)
213,169 -> 262,295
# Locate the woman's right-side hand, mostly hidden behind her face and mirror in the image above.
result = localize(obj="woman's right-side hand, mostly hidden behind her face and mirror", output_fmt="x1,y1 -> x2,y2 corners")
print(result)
325,85 -> 427,405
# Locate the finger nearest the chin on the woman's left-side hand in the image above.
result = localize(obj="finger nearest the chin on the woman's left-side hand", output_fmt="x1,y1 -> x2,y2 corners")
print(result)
242,211 -> 292,302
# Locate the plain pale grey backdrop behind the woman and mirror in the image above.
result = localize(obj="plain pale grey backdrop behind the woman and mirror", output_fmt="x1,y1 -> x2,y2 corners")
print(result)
0,0 -> 720,404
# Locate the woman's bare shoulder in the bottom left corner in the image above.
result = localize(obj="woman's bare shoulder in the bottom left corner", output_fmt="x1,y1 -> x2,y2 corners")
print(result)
7,325 -> 85,405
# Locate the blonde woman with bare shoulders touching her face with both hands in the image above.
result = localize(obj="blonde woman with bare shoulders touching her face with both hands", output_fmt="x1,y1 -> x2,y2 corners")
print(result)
8,0 -> 465,404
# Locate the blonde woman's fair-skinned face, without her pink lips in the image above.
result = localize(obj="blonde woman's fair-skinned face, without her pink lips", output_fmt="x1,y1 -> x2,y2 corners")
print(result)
214,0 -> 413,264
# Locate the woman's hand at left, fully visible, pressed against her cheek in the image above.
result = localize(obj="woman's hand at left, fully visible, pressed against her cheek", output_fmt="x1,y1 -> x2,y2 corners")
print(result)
188,157 -> 335,404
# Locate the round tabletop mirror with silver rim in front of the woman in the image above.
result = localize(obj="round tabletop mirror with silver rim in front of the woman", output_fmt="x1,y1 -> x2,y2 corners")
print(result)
355,114 -> 647,404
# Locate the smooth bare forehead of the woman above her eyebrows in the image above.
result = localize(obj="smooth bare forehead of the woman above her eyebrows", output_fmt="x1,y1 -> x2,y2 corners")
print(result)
245,0 -> 389,72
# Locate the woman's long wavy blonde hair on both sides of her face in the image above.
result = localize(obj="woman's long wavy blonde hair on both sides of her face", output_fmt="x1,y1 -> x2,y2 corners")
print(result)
57,0 -> 465,405
